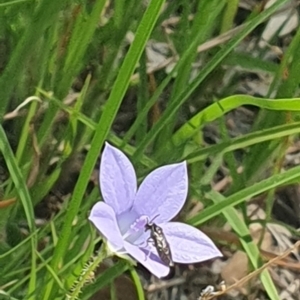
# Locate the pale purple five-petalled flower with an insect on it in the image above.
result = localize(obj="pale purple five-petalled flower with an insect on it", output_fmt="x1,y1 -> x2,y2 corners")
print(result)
89,143 -> 222,277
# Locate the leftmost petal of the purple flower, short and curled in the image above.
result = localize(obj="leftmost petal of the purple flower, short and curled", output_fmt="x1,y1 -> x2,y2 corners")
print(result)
89,202 -> 124,252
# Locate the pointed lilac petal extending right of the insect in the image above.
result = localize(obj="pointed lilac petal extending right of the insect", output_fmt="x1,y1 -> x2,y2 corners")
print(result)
160,222 -> 222,263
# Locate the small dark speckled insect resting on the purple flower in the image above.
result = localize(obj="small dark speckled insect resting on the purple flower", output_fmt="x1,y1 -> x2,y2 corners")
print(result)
145,215 -> 174,267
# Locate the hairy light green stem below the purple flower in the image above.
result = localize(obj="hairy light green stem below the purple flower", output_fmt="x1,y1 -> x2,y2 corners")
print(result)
67,244 -> 107,300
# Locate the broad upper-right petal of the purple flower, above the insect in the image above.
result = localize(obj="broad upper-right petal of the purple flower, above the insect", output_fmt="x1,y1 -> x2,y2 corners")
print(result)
134,162 -> 188,223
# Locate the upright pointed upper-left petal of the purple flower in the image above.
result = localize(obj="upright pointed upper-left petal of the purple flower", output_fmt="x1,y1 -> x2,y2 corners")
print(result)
99,143 -> 137,215
